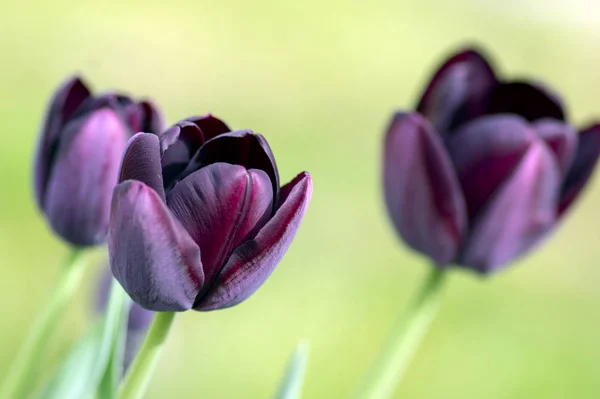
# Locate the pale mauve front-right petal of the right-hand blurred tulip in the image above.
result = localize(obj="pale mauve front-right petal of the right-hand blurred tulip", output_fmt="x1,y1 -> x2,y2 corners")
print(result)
458,141 -> 560,273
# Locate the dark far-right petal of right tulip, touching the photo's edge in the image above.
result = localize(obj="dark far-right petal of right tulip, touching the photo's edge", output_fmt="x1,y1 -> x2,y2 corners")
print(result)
558,124 -> 600,215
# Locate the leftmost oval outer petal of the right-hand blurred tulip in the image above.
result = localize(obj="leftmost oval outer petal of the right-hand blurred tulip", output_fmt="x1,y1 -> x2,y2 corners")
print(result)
384,114 -> 466,265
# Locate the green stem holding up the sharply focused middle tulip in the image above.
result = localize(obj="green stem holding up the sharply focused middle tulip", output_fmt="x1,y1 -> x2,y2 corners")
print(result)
119,312 -> 175,399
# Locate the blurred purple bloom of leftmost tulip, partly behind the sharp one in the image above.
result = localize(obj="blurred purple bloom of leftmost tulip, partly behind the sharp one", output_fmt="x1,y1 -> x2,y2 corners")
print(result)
34,77 -> 162,246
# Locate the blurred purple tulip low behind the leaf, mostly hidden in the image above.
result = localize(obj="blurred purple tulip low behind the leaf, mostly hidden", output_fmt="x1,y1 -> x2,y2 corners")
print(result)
96,265 -> 154,371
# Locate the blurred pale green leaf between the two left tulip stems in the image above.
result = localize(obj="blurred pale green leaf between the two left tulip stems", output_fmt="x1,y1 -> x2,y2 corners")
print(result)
38,280 -> 129,399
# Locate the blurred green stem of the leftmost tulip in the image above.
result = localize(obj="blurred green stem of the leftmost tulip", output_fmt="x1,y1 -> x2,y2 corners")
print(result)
0,248 -> 87,399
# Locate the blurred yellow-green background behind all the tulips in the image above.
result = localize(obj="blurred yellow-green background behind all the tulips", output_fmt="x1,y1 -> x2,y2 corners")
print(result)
0,0 -> 600,399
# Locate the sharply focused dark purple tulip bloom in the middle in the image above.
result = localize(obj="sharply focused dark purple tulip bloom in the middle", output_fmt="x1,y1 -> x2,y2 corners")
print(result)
108,115 -> 312,311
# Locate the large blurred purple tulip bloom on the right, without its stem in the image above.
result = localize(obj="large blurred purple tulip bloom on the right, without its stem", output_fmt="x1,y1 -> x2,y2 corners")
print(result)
384,46 -> 600,273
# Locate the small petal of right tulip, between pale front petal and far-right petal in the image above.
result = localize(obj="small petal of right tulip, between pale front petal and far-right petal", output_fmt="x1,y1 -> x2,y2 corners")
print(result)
533,119 -> 577,176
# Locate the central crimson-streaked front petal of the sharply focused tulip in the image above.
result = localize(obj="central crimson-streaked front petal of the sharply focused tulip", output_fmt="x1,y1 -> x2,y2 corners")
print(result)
167,163 -> 273,290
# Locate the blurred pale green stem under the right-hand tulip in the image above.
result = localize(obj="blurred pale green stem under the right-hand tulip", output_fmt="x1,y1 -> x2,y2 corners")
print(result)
355,267 -> 446,399
